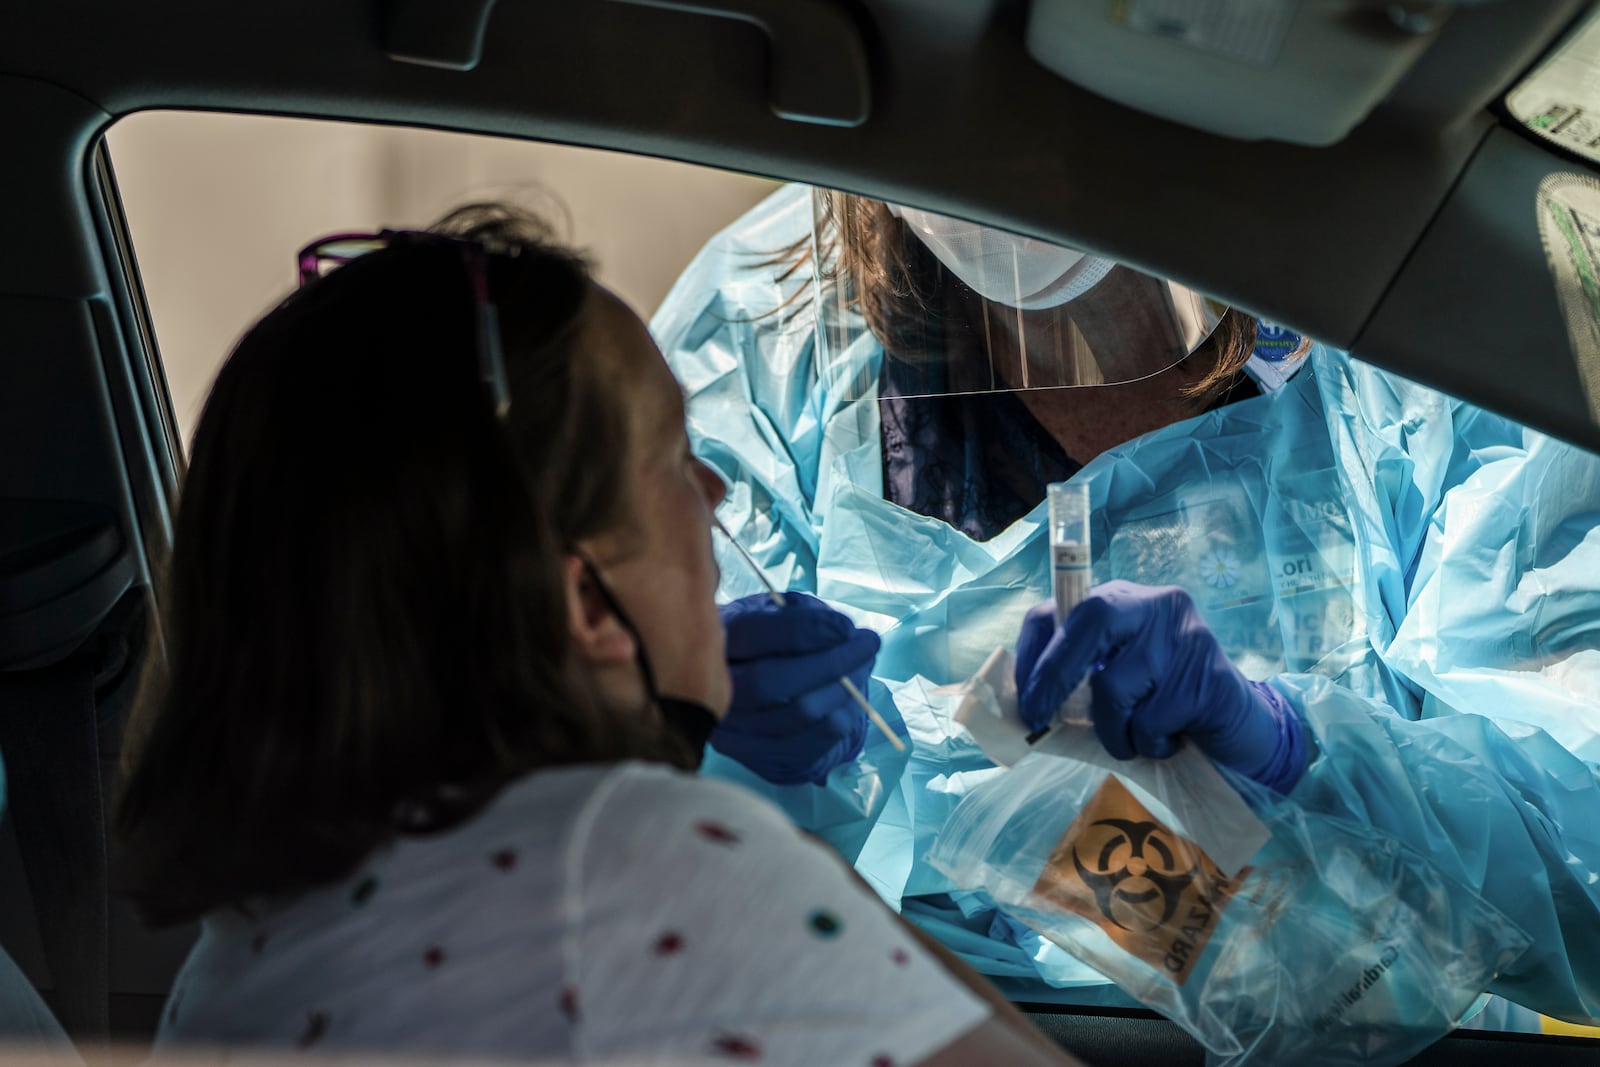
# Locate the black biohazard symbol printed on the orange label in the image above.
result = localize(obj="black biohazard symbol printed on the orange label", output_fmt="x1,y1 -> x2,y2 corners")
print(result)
1072,819 -> 1198,933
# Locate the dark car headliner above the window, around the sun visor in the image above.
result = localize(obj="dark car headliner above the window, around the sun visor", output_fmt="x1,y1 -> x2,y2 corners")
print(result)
0,0 -> 1600,446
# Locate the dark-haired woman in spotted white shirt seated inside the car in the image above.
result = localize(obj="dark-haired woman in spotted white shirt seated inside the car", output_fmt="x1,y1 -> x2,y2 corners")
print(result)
117,210 -> 1069,1067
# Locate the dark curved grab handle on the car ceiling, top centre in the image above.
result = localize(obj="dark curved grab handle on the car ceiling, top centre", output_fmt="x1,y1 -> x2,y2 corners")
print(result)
614,0 -> 872,126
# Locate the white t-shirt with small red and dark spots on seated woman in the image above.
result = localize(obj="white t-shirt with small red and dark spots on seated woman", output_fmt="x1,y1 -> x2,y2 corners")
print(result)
157,763 -> 990,1067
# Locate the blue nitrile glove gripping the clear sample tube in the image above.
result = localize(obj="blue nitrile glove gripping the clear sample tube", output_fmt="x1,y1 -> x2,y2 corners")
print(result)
1016,581 -> 1310,793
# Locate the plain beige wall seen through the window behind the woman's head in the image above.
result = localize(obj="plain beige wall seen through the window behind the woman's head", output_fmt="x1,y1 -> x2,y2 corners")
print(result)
107,112 -> 773,442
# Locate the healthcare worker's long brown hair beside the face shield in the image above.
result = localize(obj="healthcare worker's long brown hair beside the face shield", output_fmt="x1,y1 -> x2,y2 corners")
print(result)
779,190 -> 1256,413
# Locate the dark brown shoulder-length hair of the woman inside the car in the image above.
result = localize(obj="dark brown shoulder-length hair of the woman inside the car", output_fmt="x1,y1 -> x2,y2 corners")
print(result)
117,206 -> 686,921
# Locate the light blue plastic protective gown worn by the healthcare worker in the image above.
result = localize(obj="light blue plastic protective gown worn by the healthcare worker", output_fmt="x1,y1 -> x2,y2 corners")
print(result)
651,187 -> 1600,1022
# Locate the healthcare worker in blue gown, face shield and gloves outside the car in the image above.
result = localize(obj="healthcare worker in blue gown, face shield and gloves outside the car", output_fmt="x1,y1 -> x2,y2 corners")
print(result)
675,186 -> 1600,1024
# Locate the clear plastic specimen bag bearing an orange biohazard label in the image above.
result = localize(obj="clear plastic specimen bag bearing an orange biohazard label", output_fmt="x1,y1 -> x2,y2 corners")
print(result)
930,752 -> 1530,1065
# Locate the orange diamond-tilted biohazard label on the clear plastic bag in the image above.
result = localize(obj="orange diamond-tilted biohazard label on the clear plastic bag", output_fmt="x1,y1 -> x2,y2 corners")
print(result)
1034,776 -> 1248,985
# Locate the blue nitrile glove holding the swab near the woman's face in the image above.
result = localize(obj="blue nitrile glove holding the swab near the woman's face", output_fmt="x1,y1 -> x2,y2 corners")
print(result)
710,593 -> 880,785
